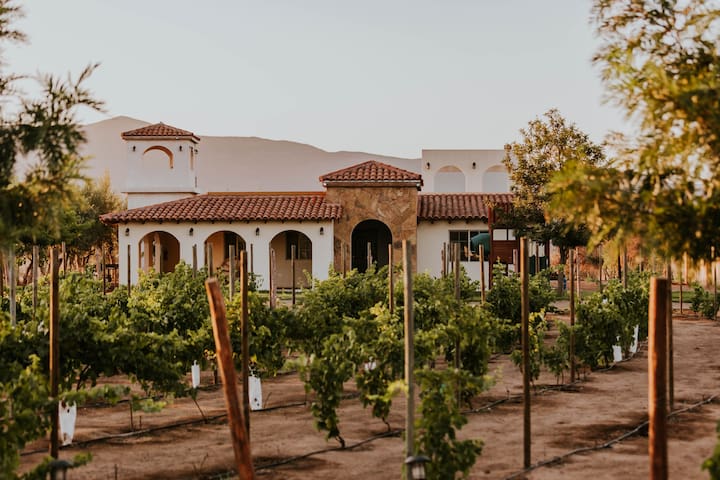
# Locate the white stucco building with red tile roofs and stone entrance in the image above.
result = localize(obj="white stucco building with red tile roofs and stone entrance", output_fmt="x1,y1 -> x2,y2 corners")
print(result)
102,123 -> 544,289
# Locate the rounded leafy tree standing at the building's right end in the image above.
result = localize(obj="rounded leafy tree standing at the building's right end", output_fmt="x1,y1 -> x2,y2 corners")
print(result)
503,109 -> 604,285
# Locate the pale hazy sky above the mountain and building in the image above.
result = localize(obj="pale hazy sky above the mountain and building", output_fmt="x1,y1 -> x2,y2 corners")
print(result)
5,0 -> 622,157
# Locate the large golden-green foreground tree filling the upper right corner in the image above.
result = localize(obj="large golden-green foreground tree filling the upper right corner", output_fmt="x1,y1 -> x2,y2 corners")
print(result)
551,0 -> 720,259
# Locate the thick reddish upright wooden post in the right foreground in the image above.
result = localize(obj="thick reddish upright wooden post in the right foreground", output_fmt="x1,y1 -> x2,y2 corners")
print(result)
648,278 -> 668,480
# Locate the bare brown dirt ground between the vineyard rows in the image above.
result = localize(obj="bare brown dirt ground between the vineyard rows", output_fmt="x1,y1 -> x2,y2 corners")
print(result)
16,306 -> 720,480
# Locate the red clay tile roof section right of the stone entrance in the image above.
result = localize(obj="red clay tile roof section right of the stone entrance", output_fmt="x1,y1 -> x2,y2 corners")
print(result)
418,193 -> 513,220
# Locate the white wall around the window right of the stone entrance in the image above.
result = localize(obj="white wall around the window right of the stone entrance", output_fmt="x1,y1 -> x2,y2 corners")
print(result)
417,221 -> 490,288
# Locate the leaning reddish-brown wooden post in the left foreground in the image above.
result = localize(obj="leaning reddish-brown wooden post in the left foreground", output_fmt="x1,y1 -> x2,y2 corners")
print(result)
205,278 -> 255,480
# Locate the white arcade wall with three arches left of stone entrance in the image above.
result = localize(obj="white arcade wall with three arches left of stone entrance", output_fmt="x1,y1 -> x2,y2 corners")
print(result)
118,221 -> 334,289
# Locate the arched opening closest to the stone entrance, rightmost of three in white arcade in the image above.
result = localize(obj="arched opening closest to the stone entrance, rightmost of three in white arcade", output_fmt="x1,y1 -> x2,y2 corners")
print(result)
270,230 -> 312,288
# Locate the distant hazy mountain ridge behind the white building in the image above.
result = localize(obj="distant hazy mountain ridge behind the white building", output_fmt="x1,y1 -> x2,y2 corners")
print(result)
77,116 -> 420,192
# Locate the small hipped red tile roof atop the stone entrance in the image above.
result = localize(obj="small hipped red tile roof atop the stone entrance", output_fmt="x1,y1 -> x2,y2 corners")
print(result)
320,160 -> 422,187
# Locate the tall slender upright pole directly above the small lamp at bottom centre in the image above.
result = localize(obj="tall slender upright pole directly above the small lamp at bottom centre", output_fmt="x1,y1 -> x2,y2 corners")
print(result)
402,240 -> 415,464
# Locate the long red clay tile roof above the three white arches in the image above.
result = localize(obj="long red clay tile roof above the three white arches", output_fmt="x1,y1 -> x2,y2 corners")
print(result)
100,193 -> 342,224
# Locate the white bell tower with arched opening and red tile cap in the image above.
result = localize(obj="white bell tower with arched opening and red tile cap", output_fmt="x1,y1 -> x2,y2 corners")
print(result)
122,123 -> 200,208
